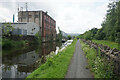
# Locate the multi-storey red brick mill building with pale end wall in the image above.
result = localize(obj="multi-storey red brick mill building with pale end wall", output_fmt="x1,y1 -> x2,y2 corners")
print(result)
18,11 -> 56,42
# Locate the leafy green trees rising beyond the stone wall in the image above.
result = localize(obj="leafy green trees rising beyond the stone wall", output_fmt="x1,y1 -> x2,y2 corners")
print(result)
80,1 -> 120,42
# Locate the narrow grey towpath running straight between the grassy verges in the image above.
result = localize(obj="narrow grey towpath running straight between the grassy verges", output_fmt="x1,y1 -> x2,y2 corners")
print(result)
65,40 -> 93,78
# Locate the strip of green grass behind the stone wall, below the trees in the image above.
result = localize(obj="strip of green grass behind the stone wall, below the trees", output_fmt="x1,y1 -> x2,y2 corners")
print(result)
92,40 -> 120,50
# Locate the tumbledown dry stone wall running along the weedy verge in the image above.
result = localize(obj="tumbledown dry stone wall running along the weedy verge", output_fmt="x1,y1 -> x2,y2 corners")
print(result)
81,39 -> 120,76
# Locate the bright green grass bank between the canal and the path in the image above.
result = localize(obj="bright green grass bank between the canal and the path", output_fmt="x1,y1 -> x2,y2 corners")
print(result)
27,40 -> 77,78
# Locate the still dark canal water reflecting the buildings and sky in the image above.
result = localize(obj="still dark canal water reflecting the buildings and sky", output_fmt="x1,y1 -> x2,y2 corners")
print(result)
2,42 -> 61,78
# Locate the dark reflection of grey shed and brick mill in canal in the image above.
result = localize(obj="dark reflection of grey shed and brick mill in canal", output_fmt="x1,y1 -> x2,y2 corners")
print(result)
3,42 -> 56,70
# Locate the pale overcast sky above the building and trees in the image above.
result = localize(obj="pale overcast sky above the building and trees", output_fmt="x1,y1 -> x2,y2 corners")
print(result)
0,0 -> 110,33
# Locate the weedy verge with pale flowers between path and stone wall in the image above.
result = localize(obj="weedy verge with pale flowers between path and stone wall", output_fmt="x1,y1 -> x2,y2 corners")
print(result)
80,40 -> 114,78
